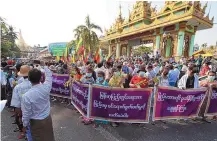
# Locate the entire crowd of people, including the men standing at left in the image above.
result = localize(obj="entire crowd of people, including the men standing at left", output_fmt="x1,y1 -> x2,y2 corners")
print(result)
1,54 -> 217,141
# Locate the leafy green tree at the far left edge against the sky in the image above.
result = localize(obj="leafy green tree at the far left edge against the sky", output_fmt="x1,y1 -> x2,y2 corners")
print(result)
0,17 -> 20,57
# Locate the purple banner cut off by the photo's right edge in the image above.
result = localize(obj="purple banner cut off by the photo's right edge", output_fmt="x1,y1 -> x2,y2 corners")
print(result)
205,87 -> 217,116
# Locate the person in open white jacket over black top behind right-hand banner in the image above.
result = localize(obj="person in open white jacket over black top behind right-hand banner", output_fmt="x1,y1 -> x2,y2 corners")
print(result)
178,66 -> 199,89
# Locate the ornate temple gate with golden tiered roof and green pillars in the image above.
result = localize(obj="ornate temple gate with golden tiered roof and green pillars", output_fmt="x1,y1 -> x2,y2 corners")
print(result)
100,1 -> 214,58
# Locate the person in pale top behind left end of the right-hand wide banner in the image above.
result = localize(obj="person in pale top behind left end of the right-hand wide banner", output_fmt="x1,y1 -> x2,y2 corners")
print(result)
155,68 -> 170,87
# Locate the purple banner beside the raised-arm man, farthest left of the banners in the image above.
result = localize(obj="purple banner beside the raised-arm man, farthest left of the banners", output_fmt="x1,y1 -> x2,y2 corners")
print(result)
50,73 -> 70,98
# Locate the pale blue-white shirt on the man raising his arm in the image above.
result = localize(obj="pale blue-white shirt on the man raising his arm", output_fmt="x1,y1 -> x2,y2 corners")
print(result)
21,66 -> 52,127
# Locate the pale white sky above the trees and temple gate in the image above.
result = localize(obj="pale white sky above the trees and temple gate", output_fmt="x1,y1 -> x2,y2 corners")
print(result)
0,0 -> 217,46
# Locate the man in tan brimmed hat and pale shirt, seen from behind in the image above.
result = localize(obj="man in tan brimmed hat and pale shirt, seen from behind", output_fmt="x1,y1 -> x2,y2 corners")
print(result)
11,65 -> 32,139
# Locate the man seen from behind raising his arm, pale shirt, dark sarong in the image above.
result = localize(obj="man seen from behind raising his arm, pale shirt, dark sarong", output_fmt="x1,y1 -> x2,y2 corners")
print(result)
21,62 -> 54,141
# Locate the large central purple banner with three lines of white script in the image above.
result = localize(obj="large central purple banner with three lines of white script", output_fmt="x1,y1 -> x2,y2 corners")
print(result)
89,86 -> 152,123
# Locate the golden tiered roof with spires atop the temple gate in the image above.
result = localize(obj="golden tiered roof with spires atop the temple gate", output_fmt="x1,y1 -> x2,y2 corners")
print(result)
101,1 -> 214,41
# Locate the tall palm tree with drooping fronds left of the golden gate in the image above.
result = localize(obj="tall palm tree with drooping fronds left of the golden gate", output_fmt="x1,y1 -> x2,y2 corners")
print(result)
74,15 -> 102,51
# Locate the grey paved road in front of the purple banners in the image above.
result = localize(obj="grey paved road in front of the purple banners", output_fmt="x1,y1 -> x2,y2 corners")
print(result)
1,103 -> 217,141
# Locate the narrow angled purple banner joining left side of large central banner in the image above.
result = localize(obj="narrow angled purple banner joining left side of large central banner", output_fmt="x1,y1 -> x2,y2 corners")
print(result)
71,81 -> 89,116
